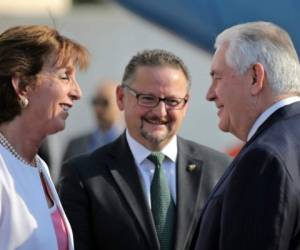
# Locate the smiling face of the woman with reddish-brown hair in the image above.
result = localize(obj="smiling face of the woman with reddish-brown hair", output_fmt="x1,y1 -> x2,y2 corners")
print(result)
24,55 -> 81,135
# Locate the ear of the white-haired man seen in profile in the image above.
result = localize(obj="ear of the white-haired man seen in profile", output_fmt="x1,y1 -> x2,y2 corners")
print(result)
250,63 -> 265,96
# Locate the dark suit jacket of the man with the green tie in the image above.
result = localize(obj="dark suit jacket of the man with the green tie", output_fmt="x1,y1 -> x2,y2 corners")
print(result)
59,134 -> 230,250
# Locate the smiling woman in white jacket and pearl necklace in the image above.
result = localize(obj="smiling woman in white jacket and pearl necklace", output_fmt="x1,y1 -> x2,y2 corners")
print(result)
0,25 -> 88,250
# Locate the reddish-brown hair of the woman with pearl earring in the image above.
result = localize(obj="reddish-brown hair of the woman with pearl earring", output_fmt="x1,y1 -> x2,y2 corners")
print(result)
0,25 -> 89,124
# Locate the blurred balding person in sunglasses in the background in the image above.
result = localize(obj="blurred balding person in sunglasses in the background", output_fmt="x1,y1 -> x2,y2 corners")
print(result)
62,80 -> 124,166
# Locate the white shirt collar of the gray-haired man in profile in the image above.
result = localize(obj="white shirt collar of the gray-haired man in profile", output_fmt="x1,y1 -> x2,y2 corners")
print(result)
247,96 -> 300,141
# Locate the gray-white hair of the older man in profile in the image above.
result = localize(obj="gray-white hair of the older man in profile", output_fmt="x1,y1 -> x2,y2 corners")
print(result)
215,22 -> 300,94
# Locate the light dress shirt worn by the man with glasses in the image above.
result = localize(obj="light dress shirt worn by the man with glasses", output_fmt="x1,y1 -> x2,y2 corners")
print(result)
126,130 -> 177,207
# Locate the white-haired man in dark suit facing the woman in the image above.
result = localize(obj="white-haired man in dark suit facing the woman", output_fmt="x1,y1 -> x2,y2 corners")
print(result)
196,22 -> 300,250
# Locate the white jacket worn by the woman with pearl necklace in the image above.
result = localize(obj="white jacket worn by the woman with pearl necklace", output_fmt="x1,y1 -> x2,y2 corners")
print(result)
0,144 -> 74,250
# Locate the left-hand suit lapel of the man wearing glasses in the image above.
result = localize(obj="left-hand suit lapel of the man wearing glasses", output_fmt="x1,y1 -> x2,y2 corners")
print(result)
108,134 -> 158,249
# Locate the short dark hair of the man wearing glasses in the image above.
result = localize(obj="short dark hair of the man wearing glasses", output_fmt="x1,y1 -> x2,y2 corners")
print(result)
122,49 -> 191,88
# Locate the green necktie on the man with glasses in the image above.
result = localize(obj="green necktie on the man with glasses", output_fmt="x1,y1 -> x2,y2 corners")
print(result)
148,153 -> 175,250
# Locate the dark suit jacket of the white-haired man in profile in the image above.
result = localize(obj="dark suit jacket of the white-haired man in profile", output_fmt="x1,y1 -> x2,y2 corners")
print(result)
196,102 -> 300,250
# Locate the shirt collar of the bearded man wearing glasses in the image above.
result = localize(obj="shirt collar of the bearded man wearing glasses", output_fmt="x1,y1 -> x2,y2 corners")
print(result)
126,129 -> 177,165
